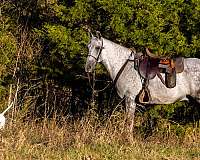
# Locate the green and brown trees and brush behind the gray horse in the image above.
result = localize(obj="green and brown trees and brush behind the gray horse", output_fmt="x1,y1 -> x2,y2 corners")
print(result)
0,0 -> 200,124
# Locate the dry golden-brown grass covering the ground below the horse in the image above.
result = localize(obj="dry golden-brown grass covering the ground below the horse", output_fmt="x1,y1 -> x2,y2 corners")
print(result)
0,112 -> 200,160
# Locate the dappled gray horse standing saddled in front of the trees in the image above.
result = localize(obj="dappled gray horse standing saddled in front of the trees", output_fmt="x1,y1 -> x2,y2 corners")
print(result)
85,33 -> 200,131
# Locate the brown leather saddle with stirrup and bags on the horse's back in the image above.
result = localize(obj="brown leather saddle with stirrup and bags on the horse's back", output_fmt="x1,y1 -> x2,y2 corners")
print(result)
134,48 -> 184,103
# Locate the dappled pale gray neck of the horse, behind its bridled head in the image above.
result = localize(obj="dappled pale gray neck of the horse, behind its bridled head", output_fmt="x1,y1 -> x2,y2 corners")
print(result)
102,39 -> 131,80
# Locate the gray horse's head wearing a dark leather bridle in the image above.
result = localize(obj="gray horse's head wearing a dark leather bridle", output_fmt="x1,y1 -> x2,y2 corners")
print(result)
85,32 -> 103,72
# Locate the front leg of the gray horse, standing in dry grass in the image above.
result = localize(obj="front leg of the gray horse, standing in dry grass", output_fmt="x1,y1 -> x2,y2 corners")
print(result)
126,97 -> 136,133
